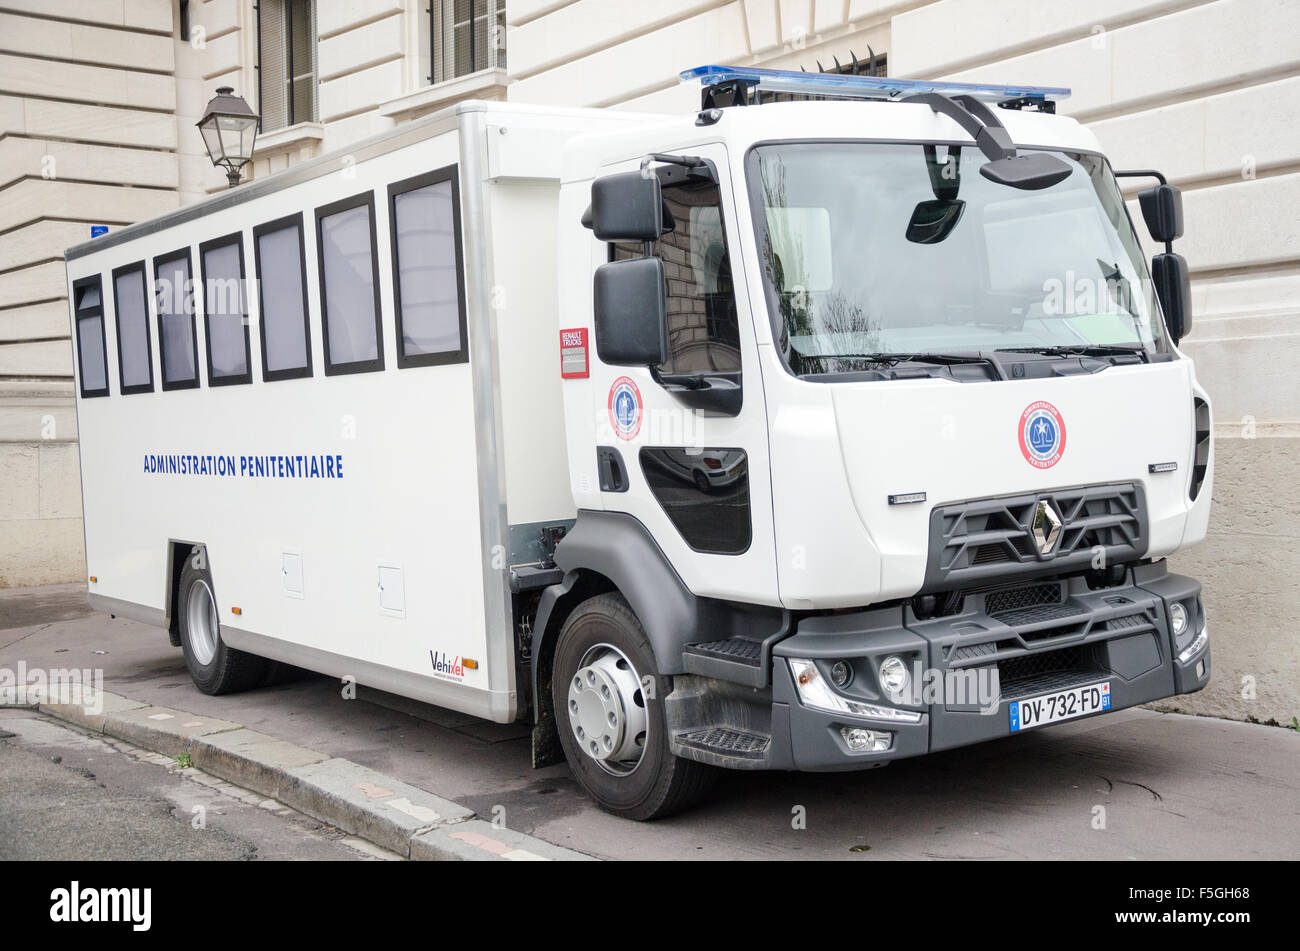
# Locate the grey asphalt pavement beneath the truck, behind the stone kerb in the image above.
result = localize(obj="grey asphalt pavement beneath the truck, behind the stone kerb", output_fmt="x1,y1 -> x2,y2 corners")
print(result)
0,586 -> 1300,861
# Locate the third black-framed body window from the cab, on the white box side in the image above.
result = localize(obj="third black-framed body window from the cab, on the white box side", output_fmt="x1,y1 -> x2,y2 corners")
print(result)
252,214 -> 312,379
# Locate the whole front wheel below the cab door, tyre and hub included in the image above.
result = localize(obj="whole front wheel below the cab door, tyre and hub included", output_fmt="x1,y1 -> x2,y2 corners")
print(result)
551,594 -> 716,820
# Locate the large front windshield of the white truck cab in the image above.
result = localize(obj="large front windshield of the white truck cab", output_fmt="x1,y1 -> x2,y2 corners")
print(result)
749,143 -> 1167,375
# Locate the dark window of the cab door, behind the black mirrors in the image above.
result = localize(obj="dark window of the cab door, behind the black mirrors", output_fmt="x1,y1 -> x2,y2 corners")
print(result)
614,179 -> 741,374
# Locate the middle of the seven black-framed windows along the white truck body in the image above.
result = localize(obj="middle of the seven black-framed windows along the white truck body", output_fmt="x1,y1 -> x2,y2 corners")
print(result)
199,234 -> 252,386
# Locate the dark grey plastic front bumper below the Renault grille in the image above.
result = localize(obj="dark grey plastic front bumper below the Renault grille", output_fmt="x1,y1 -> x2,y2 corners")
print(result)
677,563 -> 1210,770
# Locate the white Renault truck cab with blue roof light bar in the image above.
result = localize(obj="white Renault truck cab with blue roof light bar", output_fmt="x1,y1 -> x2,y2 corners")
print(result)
530,68 -> 1213,818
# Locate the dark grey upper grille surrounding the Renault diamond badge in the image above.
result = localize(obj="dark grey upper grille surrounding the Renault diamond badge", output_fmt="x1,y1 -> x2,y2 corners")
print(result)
926,482 -> 1147,590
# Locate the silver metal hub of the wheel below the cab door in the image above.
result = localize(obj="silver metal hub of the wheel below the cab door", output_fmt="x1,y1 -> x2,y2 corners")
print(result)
568,644 -> 649,776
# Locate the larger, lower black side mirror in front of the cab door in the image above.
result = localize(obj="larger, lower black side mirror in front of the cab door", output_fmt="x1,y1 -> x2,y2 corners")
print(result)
593,254 -> 668,366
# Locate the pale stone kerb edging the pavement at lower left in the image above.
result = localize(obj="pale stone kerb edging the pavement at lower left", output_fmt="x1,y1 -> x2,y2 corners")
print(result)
10,691 -> 593,861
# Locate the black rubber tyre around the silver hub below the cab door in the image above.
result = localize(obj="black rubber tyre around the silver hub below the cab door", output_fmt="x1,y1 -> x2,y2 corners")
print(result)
551,594 -> 718,820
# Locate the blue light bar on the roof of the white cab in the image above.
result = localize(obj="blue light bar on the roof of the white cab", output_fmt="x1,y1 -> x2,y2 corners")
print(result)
681,66 -> 1070,103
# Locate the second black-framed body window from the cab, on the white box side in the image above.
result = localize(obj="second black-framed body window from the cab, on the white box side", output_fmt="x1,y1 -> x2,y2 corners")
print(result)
316,191 -> 384,377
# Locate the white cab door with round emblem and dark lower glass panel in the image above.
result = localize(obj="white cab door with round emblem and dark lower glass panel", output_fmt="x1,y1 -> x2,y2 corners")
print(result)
592,144 -> 779,605
